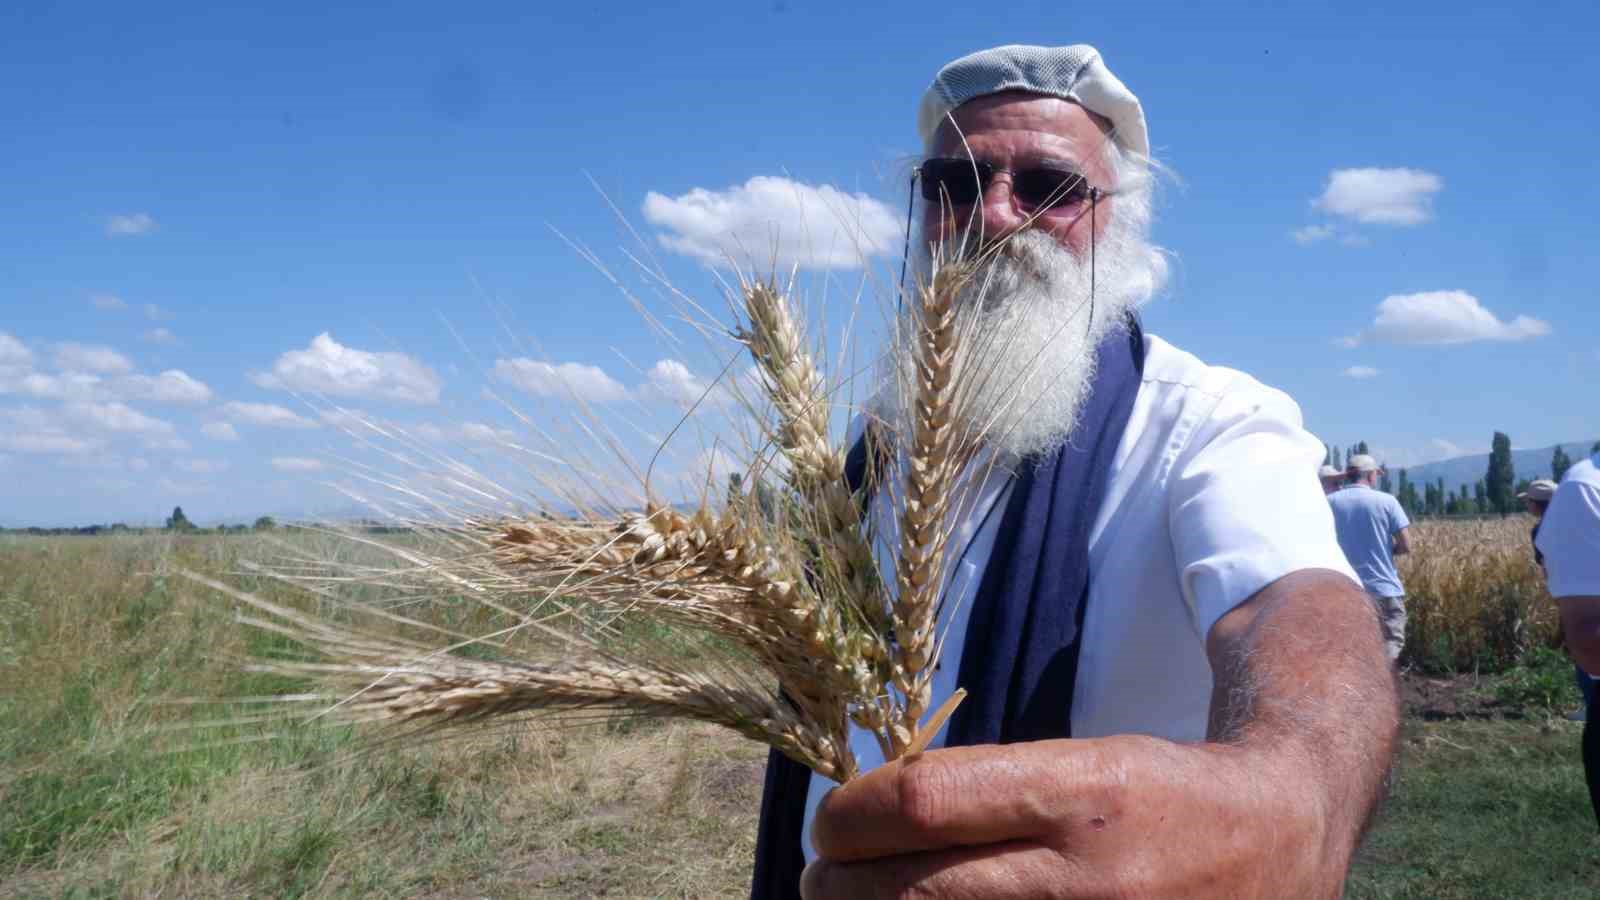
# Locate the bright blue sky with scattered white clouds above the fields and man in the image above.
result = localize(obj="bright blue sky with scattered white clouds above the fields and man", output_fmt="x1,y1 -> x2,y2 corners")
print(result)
0,0 -> 1600,525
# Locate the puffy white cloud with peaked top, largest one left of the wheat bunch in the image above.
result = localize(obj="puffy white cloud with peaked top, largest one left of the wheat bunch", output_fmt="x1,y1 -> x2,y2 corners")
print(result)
251,331 -> 440,404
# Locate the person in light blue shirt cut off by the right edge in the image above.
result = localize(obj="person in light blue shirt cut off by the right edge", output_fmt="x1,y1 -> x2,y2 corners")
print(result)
1538,453 -> 1600,825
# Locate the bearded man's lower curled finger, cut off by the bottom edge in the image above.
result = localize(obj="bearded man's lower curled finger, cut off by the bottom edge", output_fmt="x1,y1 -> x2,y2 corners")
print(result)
800,841 -> 1077,900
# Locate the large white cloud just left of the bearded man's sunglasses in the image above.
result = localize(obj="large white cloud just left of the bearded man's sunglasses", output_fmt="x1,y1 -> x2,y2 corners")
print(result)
645,176 -> 906,269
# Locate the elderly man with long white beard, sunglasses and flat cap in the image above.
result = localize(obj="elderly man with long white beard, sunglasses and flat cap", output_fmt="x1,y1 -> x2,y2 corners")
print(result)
754,45 -> 1398,898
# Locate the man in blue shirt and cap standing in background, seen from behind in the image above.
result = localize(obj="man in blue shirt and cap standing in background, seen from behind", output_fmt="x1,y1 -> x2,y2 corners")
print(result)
1328,453 -> 1411,660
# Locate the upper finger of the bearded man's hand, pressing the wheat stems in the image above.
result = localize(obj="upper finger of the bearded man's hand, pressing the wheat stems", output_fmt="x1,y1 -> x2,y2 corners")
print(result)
811,741 -> 1120,862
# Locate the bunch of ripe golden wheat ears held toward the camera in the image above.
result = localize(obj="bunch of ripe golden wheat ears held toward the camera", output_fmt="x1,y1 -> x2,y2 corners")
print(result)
197,254 -> 978,781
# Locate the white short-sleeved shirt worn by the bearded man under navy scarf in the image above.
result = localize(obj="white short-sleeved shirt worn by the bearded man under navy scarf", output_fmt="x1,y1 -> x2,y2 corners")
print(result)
803,335 -> 1360,860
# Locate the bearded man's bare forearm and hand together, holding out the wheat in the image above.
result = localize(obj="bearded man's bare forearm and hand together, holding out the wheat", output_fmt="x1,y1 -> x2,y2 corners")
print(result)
802,572 -> 1398,900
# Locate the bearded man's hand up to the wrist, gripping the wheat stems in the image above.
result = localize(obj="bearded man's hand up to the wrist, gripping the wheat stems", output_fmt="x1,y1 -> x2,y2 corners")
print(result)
800,737 -> 1344,900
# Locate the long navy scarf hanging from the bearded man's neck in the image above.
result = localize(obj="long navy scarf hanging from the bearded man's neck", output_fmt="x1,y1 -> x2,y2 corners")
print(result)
750,315 -> 1144,900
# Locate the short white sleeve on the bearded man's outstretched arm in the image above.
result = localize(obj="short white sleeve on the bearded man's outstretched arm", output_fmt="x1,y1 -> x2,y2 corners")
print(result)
1168,373 -> 1360,634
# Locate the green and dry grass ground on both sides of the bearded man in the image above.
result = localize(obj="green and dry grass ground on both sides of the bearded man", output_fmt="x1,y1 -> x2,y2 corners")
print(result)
0,530 -> 1600,898
